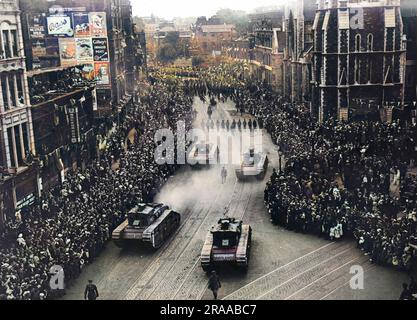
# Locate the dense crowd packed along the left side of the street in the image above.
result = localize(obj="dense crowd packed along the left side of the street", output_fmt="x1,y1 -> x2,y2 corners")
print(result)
0,81 -> 192,300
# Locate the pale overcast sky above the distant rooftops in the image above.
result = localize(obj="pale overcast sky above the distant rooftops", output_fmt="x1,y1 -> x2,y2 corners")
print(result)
131,0 -> 284,19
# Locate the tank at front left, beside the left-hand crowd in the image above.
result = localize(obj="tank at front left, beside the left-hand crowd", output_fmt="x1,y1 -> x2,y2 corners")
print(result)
112,203 -> 181,249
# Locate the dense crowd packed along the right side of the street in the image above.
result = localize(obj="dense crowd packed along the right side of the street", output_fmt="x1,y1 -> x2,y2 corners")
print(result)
189,62 -> 417,278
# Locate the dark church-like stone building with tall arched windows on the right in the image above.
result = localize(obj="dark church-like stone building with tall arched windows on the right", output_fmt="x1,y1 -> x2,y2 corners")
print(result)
312,0 -> 406,121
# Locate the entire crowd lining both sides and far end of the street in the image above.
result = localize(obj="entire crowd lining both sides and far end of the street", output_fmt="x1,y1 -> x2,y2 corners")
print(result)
0,65 -> 417,299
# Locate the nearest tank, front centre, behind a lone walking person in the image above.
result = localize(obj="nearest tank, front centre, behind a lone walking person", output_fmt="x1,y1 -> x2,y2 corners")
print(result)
200,218 -> 252,272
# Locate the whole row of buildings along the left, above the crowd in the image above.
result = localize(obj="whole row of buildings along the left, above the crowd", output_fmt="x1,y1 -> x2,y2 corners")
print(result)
0,0 -> 144,228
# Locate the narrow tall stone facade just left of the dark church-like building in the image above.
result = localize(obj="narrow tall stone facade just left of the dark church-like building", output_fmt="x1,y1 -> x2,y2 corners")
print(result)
283,0 -> 317,102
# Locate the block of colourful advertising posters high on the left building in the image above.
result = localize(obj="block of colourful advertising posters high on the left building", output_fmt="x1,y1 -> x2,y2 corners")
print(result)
34,7 -> 111,88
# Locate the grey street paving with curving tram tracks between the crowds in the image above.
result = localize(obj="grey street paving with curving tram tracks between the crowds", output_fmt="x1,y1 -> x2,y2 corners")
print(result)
64,101 -> 408,300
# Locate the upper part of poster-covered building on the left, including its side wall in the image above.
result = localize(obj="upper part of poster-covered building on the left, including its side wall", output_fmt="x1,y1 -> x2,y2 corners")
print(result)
21,0 -> 134,119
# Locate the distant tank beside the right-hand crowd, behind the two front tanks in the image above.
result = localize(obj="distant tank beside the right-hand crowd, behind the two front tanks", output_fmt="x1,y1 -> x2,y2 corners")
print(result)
236,149 -> 269,180
